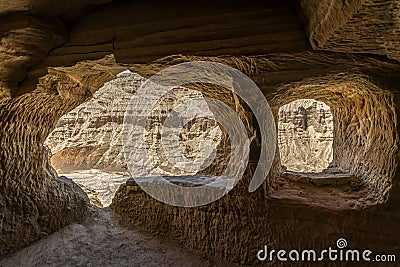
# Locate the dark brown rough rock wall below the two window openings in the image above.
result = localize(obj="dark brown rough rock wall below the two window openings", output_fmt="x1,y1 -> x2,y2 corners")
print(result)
111,178 -> 400,266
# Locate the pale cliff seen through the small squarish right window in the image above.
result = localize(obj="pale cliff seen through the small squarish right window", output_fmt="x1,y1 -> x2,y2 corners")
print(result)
278,99 -> 333,172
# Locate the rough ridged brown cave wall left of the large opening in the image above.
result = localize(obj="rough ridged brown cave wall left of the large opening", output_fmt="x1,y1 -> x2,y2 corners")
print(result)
0,57 -> 125,257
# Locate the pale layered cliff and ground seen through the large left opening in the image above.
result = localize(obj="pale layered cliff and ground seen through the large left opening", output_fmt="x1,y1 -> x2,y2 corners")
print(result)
46,72 -> 222,206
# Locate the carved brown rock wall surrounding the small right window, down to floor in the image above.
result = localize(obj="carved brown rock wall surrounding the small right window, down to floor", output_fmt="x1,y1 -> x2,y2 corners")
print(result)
111,53 -> 400,266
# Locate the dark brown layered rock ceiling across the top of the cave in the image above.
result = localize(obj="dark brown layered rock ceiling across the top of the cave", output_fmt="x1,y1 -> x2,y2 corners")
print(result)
0,0 -> 400,96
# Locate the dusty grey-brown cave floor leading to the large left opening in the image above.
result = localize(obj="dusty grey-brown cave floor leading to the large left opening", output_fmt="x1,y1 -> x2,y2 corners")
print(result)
0,207 -> 235,267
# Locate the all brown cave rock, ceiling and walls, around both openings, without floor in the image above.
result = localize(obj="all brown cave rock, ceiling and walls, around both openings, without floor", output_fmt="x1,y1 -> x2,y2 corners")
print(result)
0,0 -> 400,266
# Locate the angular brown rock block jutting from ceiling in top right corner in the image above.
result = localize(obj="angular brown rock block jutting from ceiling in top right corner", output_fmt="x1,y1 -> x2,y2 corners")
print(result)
299,0 -> 400,61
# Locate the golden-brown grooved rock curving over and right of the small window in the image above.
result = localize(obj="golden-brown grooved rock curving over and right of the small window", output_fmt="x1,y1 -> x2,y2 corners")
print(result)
270,75 -> 399,202
